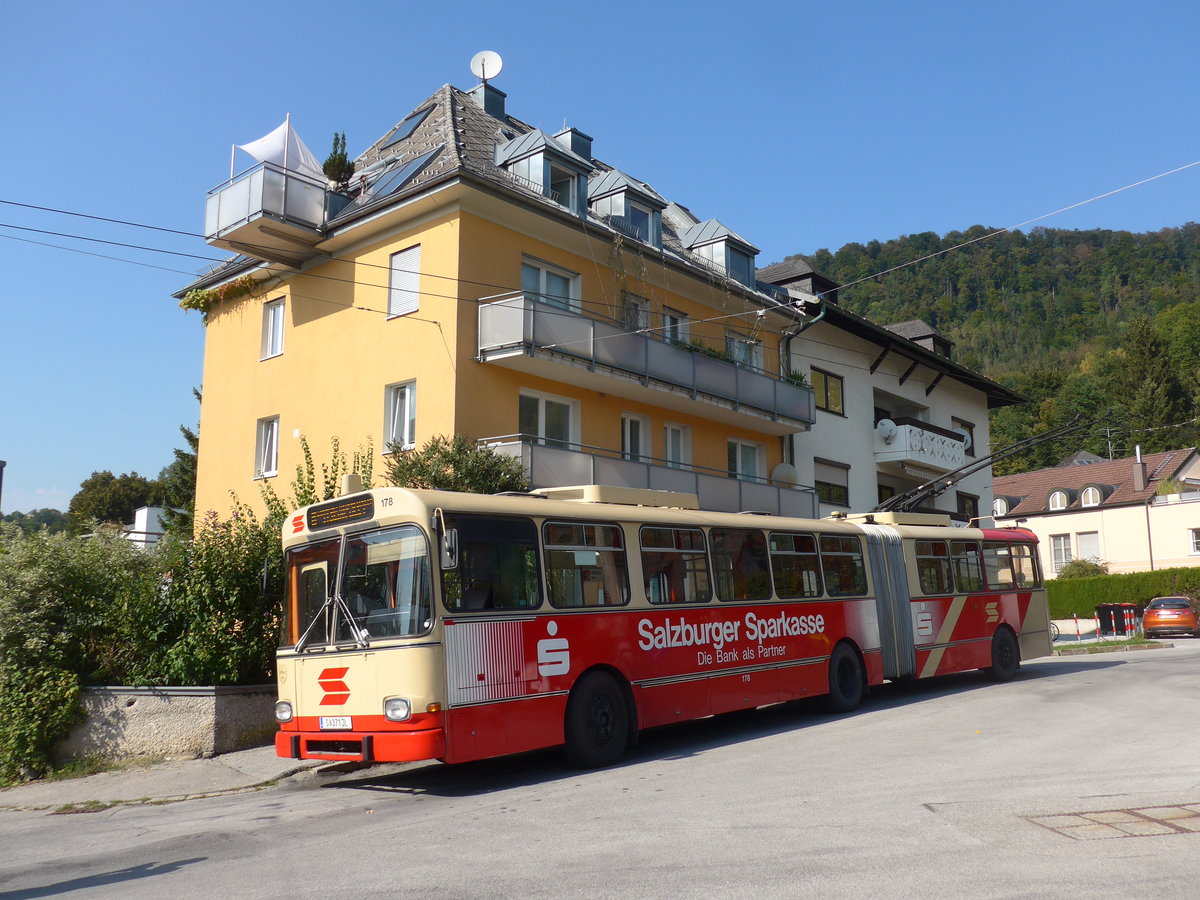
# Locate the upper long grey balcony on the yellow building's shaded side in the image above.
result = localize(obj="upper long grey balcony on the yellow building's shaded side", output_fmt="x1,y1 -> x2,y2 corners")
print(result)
479,294 -> 812,434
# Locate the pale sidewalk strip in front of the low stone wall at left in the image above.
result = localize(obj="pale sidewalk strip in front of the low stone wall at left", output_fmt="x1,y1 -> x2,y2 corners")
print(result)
0,746 -> 329,811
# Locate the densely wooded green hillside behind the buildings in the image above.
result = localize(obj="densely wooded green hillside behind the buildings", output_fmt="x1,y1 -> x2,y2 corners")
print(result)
787,222 -> 1200,474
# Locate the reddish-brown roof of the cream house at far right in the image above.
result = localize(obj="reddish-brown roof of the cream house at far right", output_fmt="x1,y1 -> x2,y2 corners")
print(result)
991,448 -> 1196,518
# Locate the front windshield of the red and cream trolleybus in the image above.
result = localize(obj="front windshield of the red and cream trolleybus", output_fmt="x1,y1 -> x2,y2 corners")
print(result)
284,526 -> 433,646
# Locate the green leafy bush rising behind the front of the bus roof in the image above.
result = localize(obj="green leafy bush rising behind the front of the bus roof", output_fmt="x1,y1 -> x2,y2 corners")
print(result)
386,434 -> 529,493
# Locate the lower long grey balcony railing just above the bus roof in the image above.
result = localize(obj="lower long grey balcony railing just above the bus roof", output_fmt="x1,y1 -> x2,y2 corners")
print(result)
479,434 -> 817,518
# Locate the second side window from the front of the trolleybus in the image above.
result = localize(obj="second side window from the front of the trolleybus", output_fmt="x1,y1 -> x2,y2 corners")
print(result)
541,522 -> 629,610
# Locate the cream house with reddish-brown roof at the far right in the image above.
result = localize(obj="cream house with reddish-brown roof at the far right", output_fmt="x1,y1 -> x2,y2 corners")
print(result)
992,448 -> 1200,577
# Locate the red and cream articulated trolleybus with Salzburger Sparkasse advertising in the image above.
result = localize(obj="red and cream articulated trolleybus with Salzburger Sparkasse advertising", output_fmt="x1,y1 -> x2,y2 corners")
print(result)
275,486 -> 1050,766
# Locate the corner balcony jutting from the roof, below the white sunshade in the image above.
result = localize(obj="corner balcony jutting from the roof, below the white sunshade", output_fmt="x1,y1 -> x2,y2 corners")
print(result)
204,162 -> 333,265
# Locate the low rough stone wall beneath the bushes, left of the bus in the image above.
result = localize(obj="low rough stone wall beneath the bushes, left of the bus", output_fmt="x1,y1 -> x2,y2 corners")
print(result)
56,684 -> 277,760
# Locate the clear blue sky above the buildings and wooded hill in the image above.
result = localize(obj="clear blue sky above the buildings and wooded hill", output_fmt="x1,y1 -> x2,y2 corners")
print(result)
0,0 -> 1200,512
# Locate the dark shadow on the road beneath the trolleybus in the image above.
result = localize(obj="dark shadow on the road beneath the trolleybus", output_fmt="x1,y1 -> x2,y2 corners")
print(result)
309,658 -> 1124,797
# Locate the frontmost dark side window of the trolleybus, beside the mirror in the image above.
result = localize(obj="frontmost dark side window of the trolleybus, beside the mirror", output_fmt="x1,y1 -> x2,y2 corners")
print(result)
442,514 -> 541,612
